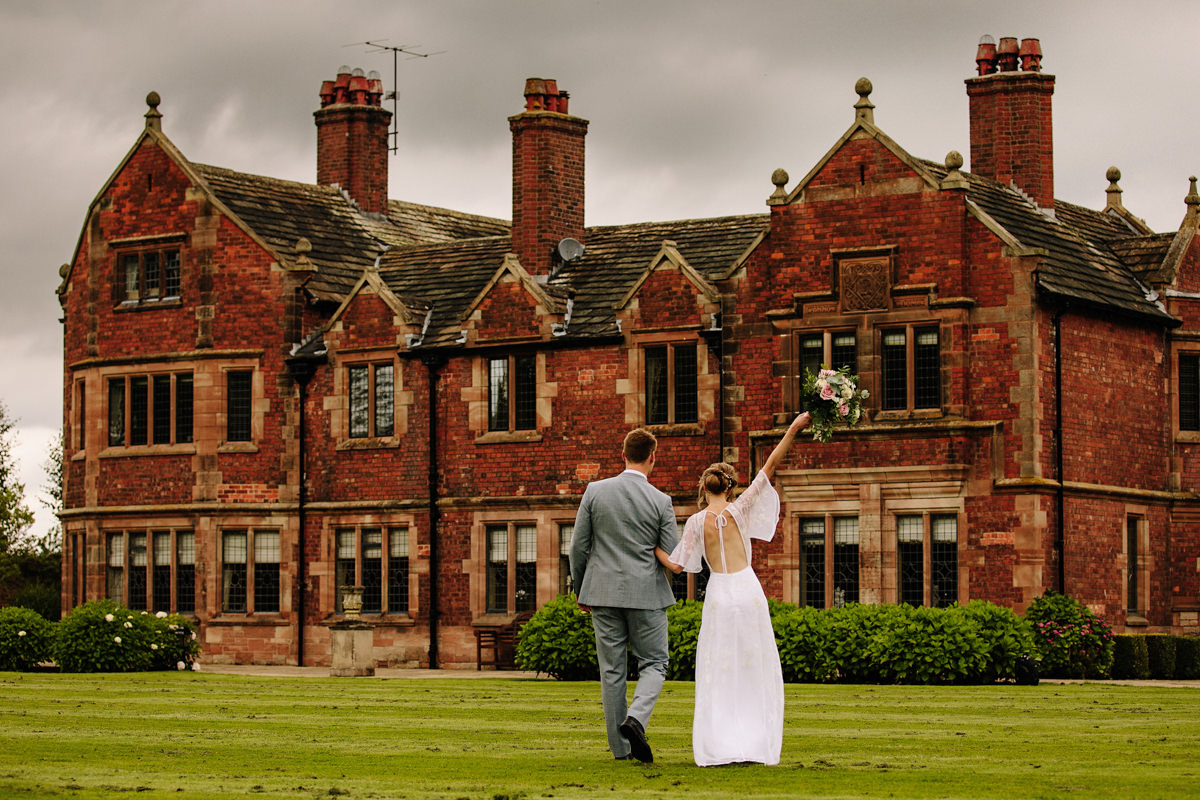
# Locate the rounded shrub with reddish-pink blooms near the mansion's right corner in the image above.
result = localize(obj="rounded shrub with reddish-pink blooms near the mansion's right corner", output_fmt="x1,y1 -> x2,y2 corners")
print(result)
1025,591 -> 1112,678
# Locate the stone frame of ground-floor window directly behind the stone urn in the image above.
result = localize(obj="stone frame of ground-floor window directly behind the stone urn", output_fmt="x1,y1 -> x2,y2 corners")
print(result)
323,515 -> 421,624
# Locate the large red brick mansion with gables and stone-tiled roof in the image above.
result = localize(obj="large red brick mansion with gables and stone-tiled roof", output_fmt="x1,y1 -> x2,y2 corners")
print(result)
59,37 -> 1200,667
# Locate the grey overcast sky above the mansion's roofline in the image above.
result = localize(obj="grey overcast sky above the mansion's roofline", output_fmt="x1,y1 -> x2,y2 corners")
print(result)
0,0 -> 1200,544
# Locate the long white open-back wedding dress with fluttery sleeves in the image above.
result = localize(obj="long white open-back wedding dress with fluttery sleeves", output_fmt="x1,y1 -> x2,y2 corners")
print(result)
671,471 -> 784,766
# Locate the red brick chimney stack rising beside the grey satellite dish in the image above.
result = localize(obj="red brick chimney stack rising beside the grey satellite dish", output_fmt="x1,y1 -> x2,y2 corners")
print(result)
509,78 -> 588,275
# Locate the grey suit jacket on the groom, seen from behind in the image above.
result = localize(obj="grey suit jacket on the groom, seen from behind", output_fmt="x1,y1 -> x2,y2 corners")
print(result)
571,470 -> 678,608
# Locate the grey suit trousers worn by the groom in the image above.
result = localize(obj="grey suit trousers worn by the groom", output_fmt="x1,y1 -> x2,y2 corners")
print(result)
592,606 -> 668,758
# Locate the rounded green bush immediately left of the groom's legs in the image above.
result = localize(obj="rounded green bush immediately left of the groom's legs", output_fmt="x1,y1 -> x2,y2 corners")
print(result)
516,594 -> 600,680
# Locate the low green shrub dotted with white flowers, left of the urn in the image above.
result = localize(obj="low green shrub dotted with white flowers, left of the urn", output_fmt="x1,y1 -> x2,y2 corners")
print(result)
54,600 -> 199,672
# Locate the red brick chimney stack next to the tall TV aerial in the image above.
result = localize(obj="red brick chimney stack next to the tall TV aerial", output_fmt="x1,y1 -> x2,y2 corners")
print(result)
313,66 -> 391,213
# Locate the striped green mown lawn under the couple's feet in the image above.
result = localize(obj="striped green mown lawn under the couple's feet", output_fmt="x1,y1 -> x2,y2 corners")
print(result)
0,673 -> 1200,800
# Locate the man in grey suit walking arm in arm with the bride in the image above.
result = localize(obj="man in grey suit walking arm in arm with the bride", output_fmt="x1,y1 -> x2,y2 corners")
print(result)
571,428 -> 678,762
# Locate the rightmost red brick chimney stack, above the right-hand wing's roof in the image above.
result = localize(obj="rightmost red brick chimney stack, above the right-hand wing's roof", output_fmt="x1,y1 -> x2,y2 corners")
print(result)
966,36 -> 1054,209
